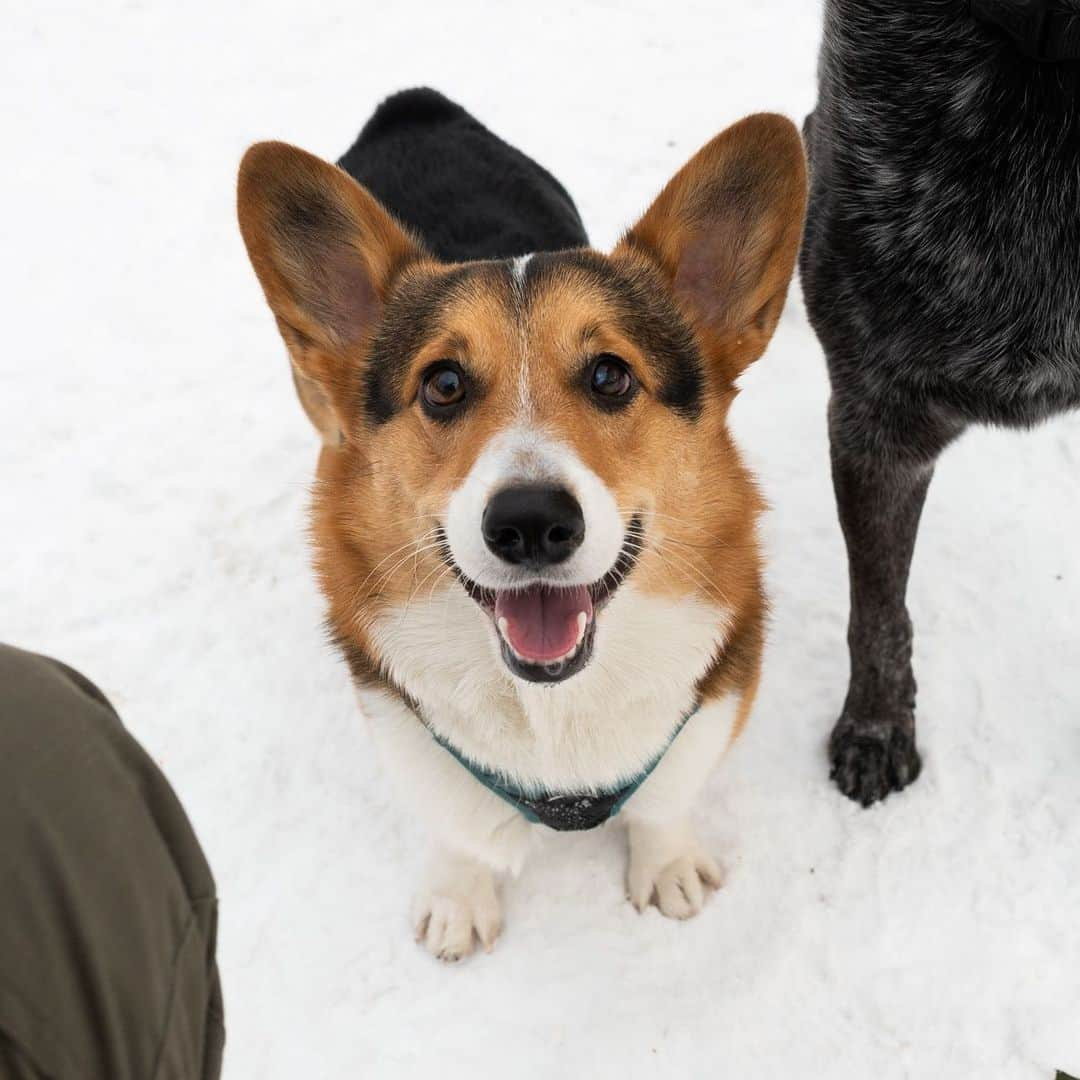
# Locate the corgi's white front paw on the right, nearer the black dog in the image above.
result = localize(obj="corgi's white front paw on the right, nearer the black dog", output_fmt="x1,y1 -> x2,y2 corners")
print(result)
627,821 -> 723,919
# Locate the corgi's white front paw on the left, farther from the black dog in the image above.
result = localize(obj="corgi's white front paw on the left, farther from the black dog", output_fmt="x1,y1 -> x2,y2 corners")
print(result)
413,854 -> 502,963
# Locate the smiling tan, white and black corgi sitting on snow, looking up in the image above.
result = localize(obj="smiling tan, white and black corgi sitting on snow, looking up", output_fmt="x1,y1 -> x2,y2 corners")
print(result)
238,90 -> 807,960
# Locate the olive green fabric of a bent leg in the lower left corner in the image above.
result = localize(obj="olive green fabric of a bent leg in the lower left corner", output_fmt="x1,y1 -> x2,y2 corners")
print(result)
0,646 -> 225,1080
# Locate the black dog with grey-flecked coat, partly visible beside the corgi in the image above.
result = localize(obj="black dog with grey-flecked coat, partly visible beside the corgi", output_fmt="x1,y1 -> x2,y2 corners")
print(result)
801,0 -> 1080,805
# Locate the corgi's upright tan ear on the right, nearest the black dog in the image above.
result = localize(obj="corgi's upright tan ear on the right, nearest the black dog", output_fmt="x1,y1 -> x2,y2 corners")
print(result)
613,113 -> 807,380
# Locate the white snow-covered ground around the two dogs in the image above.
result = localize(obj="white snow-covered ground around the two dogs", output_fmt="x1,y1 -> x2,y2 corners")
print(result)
6,0 -> 1080,1080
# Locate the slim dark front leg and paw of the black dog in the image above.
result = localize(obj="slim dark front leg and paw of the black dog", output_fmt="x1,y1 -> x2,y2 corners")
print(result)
828,408 -> 963,806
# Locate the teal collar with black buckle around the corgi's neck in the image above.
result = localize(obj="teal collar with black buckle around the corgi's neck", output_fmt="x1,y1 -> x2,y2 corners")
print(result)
418,702 -> 701,833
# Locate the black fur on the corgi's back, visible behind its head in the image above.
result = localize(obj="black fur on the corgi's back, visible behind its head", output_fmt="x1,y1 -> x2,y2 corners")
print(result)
338,89 -> 589,261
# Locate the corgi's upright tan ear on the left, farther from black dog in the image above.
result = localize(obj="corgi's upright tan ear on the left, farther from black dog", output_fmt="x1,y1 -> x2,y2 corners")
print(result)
237,143 -> 426,445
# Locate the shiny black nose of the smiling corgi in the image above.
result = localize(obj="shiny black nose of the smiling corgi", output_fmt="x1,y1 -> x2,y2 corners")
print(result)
481,486 -> 585,567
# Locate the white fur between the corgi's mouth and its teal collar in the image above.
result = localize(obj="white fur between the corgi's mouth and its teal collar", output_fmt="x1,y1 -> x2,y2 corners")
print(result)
374,583 -> 728,792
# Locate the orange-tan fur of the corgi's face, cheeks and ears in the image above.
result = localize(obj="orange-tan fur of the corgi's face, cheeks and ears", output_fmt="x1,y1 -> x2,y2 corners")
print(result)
239,117 -> 806,727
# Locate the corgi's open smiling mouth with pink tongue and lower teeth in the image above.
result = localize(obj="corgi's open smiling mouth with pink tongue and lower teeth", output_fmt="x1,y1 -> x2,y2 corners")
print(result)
444,516 -> 644,683
